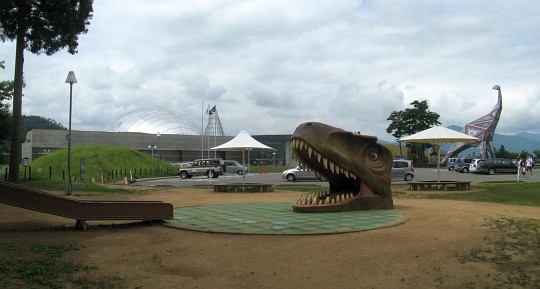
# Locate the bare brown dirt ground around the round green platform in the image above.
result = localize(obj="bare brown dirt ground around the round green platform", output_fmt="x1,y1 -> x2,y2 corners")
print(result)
0,189 -> 540,289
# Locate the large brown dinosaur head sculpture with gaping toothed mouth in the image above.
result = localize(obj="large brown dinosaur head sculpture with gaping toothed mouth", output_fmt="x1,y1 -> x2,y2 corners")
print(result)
291,122 -> 393,212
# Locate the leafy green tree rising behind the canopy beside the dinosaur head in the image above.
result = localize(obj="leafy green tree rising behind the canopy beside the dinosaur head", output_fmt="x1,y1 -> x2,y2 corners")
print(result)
386,100 -> 441,162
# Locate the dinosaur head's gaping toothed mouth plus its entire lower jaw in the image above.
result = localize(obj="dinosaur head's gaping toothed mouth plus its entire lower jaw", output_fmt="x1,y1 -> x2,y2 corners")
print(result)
291,137 -> 392,212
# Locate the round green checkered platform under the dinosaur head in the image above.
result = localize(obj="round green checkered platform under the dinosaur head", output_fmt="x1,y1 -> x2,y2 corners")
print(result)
165,203 -> 407,235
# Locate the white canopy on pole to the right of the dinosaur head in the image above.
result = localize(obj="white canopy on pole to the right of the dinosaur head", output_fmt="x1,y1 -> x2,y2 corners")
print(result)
399,125 -> 478,182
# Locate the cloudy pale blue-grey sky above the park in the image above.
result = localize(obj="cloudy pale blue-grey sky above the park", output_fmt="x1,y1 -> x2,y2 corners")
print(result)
0,0 -> 540,140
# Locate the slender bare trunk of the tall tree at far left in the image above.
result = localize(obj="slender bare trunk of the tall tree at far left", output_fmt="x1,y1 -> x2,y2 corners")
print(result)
8,28 -> 25,183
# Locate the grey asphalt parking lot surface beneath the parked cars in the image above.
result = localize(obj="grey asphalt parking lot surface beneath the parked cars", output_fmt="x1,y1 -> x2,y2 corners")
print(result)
135,168 -> 540,187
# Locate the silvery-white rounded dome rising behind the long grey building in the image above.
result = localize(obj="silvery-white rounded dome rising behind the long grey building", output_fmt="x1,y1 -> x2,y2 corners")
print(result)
109,107 -> 200,135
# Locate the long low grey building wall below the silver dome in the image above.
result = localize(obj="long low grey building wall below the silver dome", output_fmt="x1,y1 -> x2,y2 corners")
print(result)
22,129 -> 291,164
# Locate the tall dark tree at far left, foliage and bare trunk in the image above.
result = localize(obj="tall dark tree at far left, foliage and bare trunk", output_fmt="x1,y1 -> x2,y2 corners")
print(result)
0,0 -> 93,183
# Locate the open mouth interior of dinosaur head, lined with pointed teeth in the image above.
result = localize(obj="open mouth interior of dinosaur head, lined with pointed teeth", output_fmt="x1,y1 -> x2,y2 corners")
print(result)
291,137 -> 375,212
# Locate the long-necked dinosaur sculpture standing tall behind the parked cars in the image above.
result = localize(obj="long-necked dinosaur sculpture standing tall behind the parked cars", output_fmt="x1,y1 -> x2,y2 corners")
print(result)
442,85 -> 502,163
